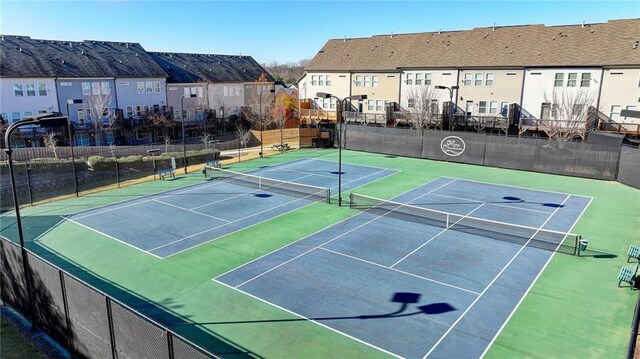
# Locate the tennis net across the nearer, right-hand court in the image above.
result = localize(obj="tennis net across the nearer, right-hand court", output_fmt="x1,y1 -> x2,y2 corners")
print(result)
349,193 -> 581,256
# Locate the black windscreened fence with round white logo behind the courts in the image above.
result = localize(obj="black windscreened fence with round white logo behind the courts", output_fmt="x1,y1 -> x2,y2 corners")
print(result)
345,125 -> 640,188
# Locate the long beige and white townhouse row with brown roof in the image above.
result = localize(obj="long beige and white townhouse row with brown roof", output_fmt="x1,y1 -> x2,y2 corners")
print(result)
299,19 -> 640,139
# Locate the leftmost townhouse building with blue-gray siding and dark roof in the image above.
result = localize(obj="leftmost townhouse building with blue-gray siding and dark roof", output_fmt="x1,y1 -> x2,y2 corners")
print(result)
0,36 -> 167,145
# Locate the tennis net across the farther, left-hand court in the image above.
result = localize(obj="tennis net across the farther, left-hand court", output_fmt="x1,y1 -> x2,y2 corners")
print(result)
204,166 -> 331,203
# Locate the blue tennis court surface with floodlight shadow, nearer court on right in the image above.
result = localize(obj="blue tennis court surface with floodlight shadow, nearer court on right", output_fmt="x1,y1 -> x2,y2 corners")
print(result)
214,177 -> 591,358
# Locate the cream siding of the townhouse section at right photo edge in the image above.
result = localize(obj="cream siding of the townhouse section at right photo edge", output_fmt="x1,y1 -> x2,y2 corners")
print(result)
599,68 -> 640,123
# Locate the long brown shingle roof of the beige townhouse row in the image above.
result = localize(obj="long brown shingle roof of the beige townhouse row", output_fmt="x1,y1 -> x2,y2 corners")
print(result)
305,19 -> 640,71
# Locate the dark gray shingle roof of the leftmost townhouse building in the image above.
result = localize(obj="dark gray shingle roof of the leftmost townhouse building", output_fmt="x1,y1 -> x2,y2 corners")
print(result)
0,35 -> 167,78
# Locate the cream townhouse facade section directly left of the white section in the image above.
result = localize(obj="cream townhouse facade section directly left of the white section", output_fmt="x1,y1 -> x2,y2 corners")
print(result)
457,69 -> 524,116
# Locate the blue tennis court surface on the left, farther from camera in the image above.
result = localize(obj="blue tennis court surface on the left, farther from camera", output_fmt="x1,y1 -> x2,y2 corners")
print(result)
66,159 -> 396,258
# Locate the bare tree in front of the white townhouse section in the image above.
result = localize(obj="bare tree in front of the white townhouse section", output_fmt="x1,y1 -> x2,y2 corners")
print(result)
541,88 -> 595,141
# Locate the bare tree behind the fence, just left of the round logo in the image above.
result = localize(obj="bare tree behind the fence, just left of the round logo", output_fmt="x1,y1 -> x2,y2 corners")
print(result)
402,85 -> 442,130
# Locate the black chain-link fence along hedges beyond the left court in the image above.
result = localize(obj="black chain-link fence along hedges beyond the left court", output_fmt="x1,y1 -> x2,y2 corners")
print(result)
0,134 -> 246,212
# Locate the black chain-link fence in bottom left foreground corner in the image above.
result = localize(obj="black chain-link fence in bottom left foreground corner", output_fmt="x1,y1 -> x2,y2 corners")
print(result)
0,237 -> 219,359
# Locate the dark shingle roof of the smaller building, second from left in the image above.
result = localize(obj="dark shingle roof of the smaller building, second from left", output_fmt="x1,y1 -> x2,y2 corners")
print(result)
150,52 -> 273,83
